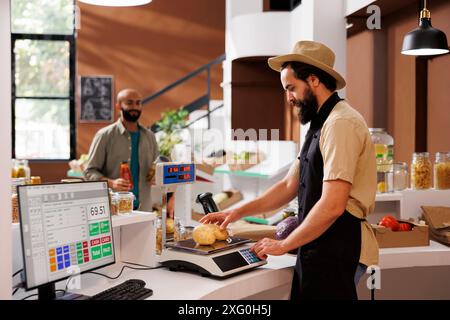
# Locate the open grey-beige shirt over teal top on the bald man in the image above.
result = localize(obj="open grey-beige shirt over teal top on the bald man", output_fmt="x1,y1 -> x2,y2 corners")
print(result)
84,119 -> 159,211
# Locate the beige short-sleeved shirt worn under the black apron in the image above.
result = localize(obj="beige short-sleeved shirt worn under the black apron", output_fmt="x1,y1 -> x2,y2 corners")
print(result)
288,100 -> 379,266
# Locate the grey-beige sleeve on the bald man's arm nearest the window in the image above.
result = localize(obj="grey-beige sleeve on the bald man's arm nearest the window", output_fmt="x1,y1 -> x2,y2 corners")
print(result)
83,133 -> 106,180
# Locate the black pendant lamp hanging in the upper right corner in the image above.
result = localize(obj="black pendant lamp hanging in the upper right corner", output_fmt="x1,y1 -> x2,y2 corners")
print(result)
402,0 -> 449,56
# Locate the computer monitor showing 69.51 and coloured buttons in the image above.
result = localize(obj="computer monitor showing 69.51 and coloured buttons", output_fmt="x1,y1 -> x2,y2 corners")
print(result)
18,181 -> 115,299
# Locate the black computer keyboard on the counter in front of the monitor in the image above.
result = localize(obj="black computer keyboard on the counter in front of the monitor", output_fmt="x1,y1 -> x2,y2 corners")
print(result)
89,279 -> 153,300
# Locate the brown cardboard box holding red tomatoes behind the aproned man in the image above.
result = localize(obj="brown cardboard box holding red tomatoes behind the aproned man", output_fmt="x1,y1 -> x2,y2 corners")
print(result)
372,219 -> 430,248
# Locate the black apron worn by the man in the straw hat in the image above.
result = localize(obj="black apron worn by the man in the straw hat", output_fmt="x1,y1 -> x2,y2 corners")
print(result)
291,93 -> 361,300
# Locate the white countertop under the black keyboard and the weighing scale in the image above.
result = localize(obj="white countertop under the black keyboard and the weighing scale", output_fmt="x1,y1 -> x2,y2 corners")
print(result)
14,254 -> 296,300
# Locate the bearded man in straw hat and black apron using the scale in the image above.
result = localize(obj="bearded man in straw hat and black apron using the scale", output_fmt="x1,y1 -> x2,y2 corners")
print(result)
201,41 -> 378,299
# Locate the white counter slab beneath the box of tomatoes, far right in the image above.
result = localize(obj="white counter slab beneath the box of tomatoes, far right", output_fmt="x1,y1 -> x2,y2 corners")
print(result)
380,240 -> 450,269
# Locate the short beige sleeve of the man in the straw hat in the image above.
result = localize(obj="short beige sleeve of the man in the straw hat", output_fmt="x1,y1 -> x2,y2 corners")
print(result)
320,119 -> 363,183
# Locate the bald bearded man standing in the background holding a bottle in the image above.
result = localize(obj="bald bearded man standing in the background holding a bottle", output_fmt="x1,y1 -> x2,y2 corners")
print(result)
84,89 -> 159,211
